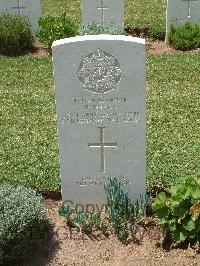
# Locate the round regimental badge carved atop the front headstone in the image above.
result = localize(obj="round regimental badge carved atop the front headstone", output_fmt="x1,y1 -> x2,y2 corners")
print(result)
78,49 -> 122,93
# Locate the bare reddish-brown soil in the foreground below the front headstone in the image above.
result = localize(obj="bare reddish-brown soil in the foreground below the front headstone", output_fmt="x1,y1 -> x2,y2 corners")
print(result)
20,199 -> 200,266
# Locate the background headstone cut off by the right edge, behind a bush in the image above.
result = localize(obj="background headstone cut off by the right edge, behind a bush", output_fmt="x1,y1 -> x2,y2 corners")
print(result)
166,0 -> 200,40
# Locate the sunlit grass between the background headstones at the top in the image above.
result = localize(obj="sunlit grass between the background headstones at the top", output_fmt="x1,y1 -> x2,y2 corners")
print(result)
42,0 -> 167,36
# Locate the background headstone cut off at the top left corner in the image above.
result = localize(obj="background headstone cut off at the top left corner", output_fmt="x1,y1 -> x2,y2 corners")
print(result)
0,0 -> 42,30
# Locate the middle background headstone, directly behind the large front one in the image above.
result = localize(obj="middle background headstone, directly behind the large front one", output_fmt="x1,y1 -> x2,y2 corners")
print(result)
81,0 -> 124,27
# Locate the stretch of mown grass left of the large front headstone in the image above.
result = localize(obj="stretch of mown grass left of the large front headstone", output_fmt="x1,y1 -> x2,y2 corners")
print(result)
0,57 -> 60,189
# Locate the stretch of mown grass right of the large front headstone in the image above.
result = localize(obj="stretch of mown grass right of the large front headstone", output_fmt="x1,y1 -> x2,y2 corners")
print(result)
147,54 -> 200,187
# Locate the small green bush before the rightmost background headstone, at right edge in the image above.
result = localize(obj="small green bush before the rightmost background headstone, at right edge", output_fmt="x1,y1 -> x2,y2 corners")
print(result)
169,22 -> 200,51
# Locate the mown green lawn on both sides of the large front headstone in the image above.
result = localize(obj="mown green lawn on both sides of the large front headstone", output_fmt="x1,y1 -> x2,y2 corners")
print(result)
0,54 -> 200,190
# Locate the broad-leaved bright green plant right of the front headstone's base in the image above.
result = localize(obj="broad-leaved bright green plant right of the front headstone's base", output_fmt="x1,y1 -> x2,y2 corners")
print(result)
153,177 -> 200,243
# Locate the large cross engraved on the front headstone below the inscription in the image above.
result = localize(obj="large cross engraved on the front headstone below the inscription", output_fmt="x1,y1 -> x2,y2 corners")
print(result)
88,127 -> 117,172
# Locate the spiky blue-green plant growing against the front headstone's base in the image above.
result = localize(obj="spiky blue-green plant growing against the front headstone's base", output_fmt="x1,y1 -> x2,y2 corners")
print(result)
59,178 -> 148,243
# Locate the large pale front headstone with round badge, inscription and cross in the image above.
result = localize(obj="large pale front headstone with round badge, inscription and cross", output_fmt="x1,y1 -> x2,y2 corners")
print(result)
52,35 -> 146,211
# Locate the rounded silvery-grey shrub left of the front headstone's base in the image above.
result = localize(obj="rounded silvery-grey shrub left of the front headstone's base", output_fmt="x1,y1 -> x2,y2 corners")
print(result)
0,185 -> 47,264
